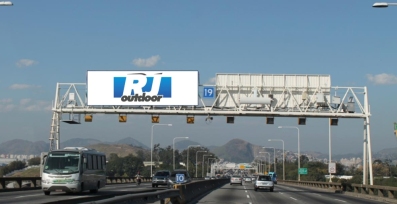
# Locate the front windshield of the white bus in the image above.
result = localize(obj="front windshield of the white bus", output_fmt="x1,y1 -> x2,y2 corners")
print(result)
43,152 -> 80,174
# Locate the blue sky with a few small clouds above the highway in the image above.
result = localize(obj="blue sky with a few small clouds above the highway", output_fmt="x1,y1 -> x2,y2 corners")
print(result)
0,0 -> 397,154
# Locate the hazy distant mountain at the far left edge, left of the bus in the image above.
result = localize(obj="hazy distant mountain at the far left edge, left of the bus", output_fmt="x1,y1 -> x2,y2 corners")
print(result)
0,139 -> 50,155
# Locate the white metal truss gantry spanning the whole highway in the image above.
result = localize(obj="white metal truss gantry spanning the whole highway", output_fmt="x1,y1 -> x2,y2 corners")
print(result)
49,74 -> 373,185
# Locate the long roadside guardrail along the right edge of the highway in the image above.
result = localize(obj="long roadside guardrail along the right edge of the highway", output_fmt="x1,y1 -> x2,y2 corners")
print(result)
279,180 -> 397,202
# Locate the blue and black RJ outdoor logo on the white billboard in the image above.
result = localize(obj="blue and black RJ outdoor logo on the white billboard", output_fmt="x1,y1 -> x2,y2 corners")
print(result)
113,73 -> 172,102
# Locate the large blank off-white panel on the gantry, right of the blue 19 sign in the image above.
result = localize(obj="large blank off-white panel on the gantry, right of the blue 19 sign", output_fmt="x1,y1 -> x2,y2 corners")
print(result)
216,73 -> 331,108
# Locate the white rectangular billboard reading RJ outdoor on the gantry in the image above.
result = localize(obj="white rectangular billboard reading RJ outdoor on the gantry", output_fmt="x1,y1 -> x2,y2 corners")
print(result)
87,71 -> 199,106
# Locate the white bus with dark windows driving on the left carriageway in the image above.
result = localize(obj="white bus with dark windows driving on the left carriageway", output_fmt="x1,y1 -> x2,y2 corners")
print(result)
40,147 -> 106,195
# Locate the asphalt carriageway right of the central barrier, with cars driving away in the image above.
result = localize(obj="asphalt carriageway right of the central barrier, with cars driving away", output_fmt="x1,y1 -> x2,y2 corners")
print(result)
191,183 -> 382,204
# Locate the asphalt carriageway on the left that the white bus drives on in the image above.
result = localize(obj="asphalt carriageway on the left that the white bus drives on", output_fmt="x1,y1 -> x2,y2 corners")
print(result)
0,183 -> 161,204
